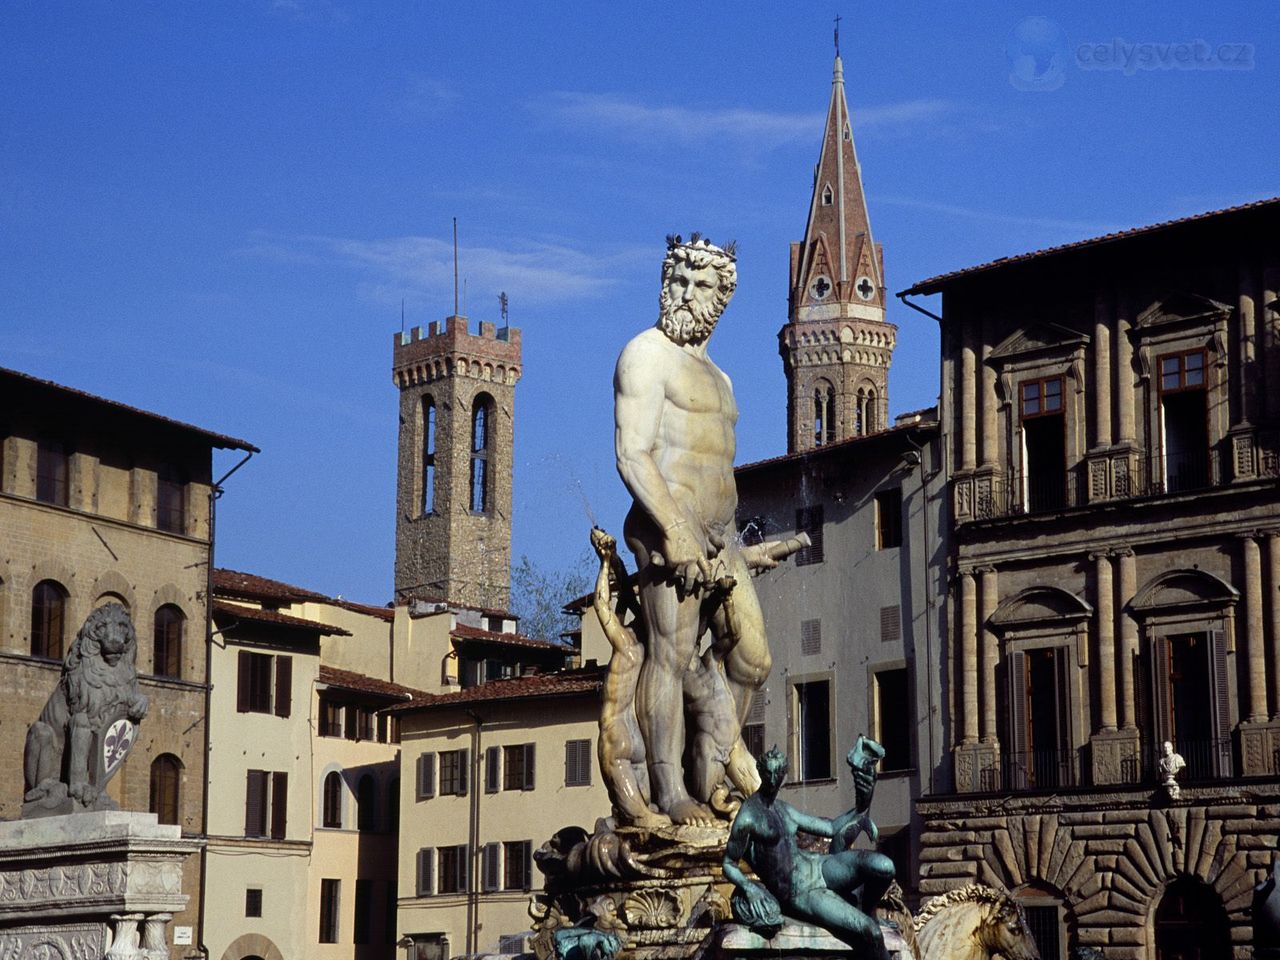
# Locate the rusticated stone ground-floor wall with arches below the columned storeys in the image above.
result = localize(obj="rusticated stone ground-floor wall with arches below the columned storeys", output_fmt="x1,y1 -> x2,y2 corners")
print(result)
918,783 -> 1280,960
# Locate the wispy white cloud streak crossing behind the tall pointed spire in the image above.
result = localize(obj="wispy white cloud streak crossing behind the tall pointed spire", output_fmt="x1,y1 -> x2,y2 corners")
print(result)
532,91 -> 956,148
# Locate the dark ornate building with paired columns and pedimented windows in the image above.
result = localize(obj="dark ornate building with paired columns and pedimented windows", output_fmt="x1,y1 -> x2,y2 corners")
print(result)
904,200 -> 1280,960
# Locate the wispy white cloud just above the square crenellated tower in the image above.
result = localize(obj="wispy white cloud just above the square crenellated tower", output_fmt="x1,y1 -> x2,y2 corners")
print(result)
239,233 -> 640,303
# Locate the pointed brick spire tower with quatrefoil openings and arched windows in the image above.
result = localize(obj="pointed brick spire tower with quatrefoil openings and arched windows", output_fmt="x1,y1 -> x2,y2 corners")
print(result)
778,38 -> 897,453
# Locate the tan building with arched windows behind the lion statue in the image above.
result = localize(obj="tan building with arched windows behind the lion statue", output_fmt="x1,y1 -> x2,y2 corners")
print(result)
0,370 -> 256,957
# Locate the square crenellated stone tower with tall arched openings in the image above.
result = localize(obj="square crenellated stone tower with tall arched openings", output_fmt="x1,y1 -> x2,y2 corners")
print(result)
392,316 -> 521,612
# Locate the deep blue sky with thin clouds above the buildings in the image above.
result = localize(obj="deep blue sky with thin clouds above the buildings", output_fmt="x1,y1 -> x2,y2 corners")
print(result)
0,0 -> 1280,603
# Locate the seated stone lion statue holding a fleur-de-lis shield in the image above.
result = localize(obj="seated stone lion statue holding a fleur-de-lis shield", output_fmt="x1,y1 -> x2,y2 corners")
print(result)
23,603 -> 148,815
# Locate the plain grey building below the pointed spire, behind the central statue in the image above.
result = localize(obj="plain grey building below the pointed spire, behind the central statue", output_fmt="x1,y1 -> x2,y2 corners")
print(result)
735,411 -> 947,900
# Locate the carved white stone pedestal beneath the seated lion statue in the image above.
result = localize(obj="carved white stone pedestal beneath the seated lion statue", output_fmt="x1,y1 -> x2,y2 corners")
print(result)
0,810 -> 204,960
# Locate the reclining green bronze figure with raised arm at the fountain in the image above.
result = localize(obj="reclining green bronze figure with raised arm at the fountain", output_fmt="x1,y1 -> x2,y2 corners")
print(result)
723,737 -> 893,960
